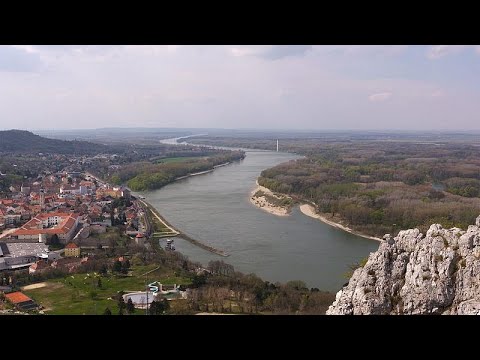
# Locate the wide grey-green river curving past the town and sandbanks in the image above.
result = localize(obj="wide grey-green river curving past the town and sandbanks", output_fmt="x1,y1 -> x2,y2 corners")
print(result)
142,142 -> 379,291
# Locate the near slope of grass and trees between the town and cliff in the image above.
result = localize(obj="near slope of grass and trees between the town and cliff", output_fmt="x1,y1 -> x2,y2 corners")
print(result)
18,239 -> 334,315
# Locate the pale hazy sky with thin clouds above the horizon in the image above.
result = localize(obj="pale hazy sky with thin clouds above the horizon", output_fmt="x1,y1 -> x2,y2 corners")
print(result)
0,45 -> 480,130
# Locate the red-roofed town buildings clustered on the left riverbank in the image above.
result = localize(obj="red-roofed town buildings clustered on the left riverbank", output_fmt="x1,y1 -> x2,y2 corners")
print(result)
0,167 -> 185,310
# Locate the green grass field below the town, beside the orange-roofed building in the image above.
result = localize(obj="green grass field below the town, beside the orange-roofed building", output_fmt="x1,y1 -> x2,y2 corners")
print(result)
25,265 -> 191,315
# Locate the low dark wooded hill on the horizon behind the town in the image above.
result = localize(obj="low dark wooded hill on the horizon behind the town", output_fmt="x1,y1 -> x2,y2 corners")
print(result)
0,130 -> 114,155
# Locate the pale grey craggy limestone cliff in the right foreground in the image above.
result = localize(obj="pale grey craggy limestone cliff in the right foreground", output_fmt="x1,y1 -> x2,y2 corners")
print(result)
327,216 -> 480,315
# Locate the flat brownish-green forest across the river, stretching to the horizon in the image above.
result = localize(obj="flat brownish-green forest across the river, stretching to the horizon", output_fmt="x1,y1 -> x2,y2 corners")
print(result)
192,137 -> 480,237
